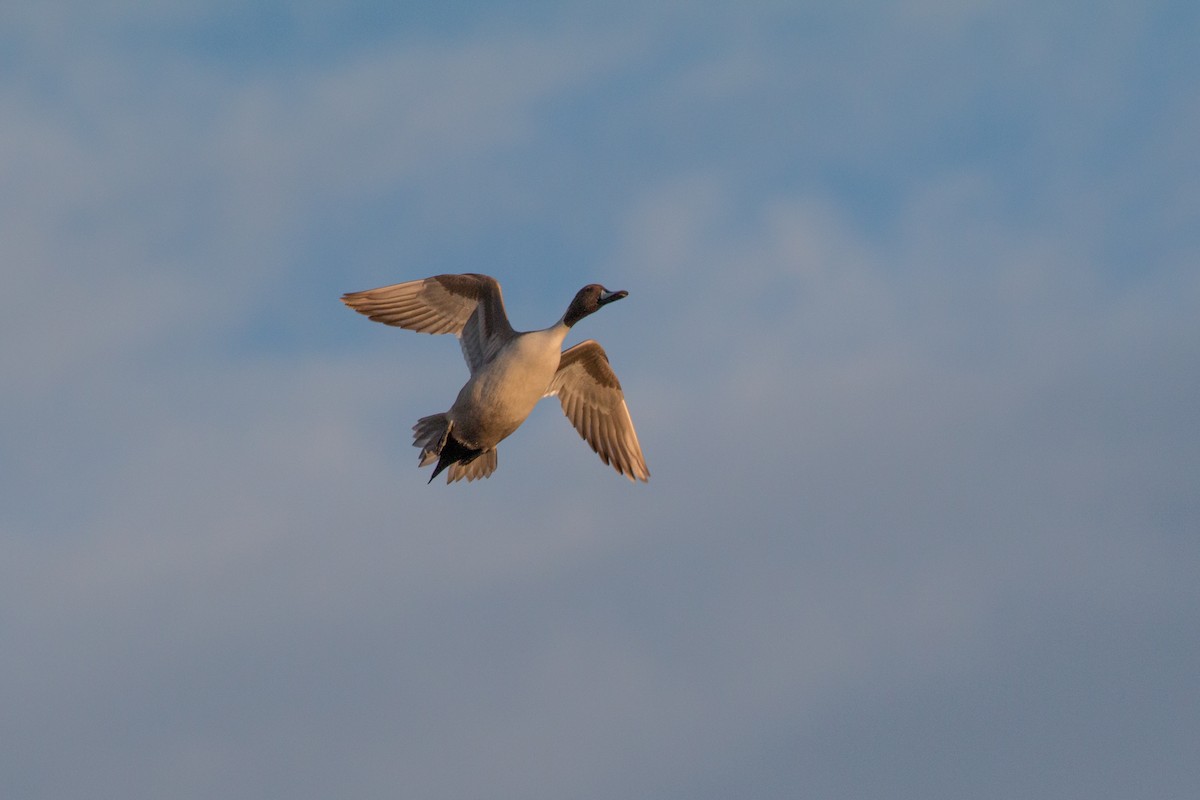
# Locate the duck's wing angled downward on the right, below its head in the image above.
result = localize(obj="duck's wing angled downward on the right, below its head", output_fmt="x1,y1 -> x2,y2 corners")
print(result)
546,339 -> 650,481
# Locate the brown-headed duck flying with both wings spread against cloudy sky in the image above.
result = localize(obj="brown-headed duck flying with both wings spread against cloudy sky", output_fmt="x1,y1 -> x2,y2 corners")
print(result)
342,272 -> 650,483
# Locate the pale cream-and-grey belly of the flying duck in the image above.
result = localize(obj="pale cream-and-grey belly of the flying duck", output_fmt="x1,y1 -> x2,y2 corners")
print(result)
448,337 -> 562,450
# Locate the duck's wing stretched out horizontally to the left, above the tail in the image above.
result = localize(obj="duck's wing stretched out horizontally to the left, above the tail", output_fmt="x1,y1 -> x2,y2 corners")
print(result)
342,272 -> 514,373
